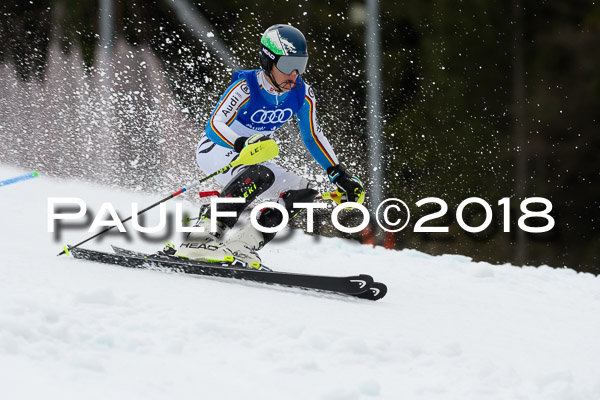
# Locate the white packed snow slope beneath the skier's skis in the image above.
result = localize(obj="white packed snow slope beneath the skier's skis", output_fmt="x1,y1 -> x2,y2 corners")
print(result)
0,166 -> 600,400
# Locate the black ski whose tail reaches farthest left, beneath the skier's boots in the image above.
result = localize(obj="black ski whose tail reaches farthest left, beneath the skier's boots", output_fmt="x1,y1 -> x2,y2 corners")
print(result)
70,247 -> 380,298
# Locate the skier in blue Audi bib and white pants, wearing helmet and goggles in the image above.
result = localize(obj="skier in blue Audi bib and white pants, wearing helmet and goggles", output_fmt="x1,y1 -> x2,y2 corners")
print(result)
175,25 -> 364,268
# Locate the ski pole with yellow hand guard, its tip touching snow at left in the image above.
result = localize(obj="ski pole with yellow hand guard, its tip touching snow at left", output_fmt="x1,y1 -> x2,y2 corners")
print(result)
57,139 -> 279,256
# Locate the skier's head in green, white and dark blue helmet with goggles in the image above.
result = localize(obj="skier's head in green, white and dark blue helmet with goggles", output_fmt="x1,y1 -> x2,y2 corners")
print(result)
259,24 -> 308,92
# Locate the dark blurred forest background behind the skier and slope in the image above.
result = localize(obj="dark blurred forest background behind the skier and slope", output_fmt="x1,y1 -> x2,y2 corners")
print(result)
0,0 -> 600,274
